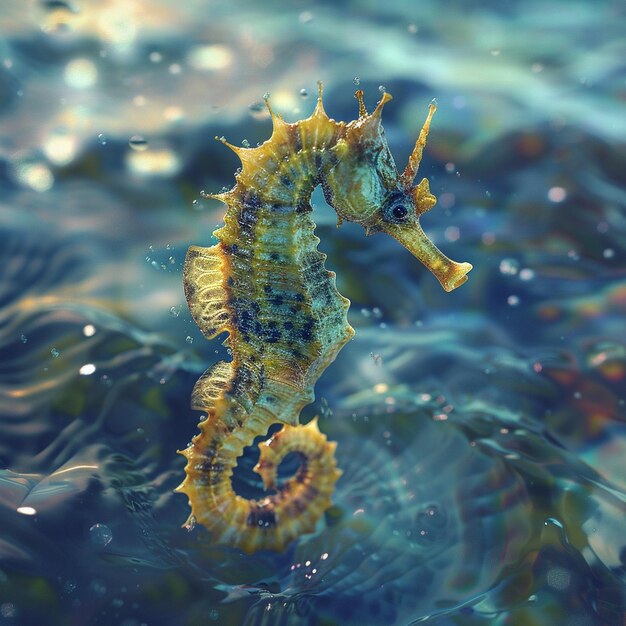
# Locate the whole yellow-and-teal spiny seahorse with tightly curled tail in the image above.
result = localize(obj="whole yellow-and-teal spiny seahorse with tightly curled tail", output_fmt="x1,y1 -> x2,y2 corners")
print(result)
178,83 -> 472,552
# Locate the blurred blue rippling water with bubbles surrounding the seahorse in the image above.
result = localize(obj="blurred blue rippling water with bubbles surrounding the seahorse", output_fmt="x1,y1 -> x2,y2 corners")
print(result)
0,0 -> 626,626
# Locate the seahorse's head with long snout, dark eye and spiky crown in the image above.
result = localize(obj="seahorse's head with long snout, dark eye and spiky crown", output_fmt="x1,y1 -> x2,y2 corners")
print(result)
325,91 -> 472,291
